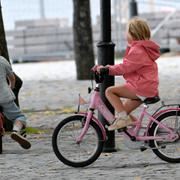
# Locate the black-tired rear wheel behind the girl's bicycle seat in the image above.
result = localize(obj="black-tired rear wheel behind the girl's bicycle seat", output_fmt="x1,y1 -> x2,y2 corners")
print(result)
149,111 -> 180,163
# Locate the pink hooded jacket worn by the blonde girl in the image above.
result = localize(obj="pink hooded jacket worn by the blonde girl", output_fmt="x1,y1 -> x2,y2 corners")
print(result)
109,40 -> 160,97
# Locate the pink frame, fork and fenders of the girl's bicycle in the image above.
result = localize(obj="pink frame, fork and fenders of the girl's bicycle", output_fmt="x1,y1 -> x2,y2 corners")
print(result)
76,85 -> 180,143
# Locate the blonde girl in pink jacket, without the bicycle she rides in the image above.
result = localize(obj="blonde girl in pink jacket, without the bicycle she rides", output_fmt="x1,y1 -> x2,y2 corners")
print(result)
93,18 -> 160,131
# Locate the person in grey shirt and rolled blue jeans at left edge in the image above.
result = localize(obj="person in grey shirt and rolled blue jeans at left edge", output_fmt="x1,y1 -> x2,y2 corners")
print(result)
0,56 -> 31,149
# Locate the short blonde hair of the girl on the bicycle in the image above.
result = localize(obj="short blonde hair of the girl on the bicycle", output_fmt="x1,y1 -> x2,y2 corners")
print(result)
127,18 -> 151,40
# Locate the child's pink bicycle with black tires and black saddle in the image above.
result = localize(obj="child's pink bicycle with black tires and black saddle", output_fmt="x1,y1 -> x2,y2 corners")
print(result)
52,70 -> 180,167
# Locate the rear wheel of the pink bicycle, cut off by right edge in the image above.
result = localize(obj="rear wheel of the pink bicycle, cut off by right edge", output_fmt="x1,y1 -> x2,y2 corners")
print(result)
149,111 -> 180,163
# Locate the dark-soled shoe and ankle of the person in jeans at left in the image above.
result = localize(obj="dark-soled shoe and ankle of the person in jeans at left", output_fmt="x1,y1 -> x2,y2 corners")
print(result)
11,121 -> 31,149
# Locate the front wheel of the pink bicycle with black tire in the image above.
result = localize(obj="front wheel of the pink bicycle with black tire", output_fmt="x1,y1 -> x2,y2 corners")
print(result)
52,115 -> 104,167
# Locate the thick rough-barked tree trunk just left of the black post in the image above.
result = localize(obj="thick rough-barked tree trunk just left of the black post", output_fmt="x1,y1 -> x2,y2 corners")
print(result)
73,0 -> 94,80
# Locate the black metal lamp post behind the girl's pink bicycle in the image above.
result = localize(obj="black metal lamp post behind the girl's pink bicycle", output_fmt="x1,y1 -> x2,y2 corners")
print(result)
97,0 -> 116,152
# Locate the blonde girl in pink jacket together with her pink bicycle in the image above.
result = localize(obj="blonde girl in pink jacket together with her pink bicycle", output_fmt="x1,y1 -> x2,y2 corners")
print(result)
52,18 -> 180,167
